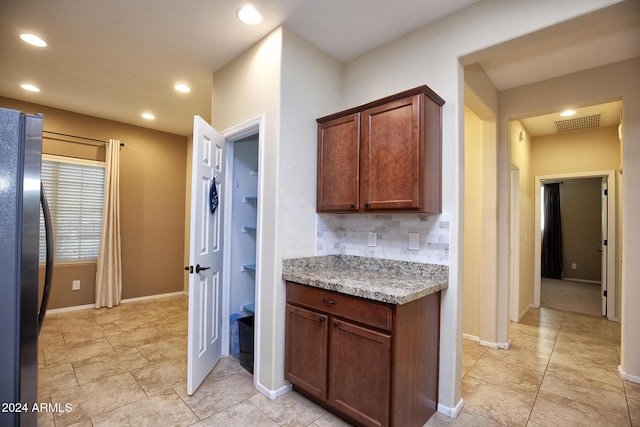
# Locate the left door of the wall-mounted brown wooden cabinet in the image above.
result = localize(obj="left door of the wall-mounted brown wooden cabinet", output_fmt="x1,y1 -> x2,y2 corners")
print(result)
316,113 -> 360,212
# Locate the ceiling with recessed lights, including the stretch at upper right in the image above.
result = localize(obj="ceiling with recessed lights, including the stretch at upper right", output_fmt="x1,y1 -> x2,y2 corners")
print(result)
0,0 -> 640,135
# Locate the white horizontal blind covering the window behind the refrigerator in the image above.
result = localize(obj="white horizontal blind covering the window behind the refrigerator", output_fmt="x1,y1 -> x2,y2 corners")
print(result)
40,155 -> 105,264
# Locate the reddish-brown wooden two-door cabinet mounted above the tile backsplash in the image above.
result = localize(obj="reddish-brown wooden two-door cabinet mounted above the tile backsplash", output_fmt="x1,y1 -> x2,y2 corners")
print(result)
316,86 -> 444,213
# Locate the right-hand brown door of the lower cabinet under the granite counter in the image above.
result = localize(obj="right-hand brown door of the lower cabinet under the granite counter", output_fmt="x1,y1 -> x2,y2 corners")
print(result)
329,319 -> 391,426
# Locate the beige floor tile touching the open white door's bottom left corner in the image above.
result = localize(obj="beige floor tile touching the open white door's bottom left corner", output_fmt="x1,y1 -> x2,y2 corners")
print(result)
131,357 -> 187,396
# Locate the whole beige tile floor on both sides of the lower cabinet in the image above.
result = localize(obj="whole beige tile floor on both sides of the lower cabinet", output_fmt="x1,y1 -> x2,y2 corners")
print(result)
38,296 -> 640,427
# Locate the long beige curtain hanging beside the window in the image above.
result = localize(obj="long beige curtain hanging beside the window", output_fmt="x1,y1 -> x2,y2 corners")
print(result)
96,139 -> 122,308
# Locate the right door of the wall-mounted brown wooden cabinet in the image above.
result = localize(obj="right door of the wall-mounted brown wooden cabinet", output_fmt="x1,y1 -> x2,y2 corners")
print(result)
360,95 -> 424,210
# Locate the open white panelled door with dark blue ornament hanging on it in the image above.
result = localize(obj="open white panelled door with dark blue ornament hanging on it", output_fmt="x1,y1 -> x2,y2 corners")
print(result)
187,116 -> 225,394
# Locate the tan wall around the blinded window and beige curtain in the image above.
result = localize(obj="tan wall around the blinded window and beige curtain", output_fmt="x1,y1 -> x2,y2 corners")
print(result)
0,98 -> 187,309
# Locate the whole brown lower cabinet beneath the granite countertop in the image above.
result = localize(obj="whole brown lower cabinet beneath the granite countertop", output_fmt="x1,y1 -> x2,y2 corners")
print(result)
285,282 -> 440,426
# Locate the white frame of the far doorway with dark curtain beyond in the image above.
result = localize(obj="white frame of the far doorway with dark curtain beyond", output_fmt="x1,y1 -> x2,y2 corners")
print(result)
533,170 -> 618,320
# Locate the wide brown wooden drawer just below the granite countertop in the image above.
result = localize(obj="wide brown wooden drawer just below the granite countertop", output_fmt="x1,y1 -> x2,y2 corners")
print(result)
287,282 -> 392,331
